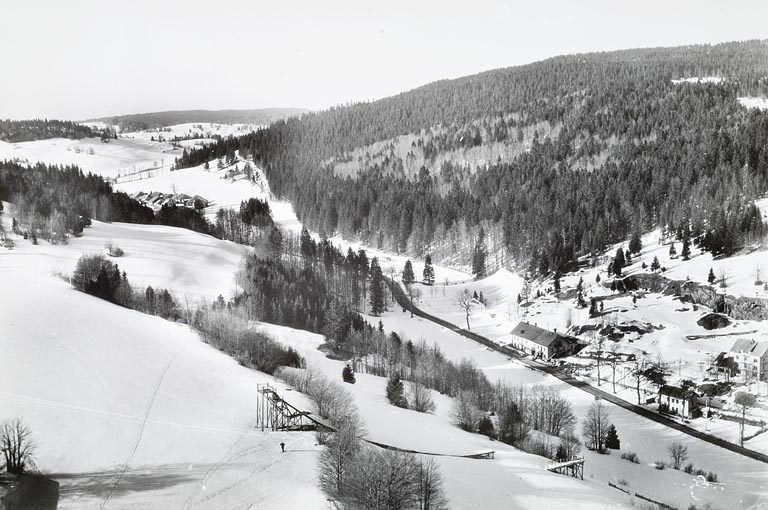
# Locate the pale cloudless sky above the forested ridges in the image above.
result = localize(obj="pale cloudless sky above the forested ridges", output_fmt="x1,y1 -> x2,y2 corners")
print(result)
0,0 -> 768,120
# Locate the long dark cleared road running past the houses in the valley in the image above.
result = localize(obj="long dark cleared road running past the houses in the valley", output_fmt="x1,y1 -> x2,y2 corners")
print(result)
385,277 -> 768,464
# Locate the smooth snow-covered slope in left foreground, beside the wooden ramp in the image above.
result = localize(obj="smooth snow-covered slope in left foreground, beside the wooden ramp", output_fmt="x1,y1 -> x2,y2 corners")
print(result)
0,260 -> 324,509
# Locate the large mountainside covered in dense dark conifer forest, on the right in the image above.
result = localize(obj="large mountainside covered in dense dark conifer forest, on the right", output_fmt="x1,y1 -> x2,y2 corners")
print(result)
178,41 -> 768,273
